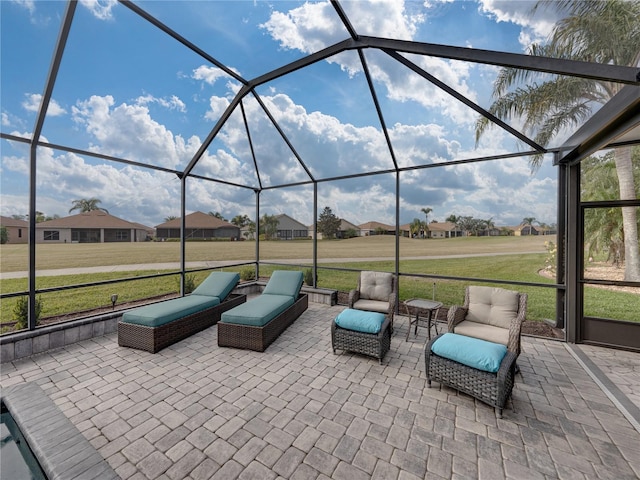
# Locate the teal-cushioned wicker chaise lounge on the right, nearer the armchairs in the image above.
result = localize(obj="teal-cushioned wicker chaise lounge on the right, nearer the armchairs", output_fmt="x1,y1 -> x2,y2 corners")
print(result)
218,270 -> 309,352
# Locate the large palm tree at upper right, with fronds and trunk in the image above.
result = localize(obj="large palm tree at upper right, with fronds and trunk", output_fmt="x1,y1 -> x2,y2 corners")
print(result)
476,0 -> 640,281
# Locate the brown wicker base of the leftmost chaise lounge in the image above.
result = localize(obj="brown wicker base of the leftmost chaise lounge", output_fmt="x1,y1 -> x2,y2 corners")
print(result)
118,293 -> 247,353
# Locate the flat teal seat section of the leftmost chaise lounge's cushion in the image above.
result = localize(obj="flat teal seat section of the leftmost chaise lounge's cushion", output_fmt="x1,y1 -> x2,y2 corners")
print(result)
122,295 -> 220,327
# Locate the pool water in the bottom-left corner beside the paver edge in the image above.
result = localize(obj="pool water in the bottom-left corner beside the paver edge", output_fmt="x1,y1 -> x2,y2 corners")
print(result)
0,404 -> 47,480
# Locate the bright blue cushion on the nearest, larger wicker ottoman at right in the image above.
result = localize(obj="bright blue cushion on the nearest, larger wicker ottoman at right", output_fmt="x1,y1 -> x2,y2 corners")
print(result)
431,333 -> 507,373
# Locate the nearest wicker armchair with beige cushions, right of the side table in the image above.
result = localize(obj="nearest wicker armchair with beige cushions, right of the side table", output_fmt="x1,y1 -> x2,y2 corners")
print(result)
447,286 -> 527,356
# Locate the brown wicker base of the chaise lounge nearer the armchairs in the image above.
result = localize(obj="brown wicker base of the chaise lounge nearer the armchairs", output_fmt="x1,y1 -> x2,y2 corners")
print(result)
218,294 -> 309,352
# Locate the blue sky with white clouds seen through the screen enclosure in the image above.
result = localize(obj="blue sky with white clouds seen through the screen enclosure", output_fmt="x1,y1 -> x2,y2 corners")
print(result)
0,0 -> 562,226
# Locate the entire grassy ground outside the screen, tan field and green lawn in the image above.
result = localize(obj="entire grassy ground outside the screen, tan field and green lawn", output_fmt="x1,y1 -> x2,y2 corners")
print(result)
0,236 -> 640,322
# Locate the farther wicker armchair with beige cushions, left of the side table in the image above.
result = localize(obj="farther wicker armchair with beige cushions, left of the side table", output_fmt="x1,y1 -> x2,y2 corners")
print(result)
349,271 -> 397,333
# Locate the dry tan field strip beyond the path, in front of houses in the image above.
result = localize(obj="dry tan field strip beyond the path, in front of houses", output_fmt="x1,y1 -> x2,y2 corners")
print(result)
0,235 -> 555,273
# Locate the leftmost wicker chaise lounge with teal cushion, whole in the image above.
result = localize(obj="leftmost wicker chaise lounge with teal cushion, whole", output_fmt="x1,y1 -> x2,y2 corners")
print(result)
118,272 -> 247,353
